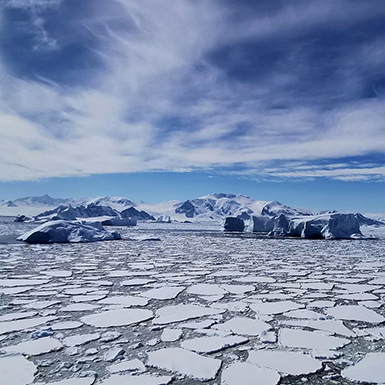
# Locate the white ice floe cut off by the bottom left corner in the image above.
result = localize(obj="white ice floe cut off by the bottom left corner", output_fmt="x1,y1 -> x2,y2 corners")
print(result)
0,355 -> 37,385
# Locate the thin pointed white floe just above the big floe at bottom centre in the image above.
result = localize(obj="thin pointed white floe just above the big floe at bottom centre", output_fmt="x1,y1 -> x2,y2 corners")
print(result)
181,336 -> 249,353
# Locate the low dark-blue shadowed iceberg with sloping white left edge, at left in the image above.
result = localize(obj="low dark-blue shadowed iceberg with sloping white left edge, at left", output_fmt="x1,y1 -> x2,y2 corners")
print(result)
17,220 -> 121,243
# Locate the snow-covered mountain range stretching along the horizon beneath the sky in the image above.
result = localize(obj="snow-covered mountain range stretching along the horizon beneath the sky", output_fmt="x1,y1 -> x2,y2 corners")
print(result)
0,193 -> 384,225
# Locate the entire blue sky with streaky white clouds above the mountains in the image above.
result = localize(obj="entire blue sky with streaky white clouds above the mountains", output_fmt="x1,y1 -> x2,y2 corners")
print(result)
0,0 -> 385,212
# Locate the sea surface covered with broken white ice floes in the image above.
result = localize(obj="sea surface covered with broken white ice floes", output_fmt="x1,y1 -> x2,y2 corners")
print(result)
0,223 -> 385,385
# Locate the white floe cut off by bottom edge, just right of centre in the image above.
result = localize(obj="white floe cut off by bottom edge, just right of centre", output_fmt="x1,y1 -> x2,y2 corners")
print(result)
221,362 -> 280,385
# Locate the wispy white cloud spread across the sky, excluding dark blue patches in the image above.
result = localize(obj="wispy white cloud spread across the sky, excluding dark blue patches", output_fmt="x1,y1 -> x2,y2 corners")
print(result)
0,0 -> 385,180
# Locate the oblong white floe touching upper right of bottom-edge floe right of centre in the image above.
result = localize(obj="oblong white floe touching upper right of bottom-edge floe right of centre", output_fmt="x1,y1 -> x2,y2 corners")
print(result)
247,350 -> 322,376
